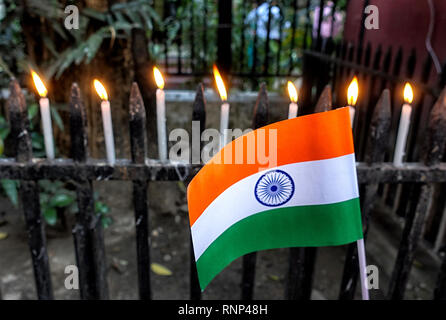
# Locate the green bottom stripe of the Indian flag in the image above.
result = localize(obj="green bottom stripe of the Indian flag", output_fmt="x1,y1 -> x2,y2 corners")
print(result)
197,198 -> 362,290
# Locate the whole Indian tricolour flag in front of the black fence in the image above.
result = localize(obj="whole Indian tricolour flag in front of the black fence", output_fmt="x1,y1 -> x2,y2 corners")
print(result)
187,108 -> 363,289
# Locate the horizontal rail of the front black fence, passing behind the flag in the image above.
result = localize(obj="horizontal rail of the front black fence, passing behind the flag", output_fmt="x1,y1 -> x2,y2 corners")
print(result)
0,158 -> 446,183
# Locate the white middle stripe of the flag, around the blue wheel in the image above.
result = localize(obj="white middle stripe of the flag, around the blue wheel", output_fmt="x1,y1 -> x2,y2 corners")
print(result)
191,153 -> 359,260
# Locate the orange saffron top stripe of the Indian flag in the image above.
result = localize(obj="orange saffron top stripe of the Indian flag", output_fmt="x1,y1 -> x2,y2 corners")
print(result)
188,108 -> 354,225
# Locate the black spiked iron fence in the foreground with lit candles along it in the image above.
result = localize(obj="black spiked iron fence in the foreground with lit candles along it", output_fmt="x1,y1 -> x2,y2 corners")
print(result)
0,76 -> 446,300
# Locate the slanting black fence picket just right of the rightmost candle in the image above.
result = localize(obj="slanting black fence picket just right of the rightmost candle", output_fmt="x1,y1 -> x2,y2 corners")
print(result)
388,88 -> 446,299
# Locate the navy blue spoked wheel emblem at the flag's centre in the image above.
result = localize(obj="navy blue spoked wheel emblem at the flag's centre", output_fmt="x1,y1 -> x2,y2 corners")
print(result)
254,170 -> 294,207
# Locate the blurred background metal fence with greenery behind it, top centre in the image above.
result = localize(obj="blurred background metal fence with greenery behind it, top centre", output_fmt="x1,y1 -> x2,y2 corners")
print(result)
161,0 -> 324,79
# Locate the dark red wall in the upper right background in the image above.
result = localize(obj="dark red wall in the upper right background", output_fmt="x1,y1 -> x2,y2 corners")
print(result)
344,0 -> 446,85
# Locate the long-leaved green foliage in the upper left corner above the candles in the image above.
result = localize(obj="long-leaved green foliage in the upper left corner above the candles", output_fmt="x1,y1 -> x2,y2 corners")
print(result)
0,0 -> 164,81
